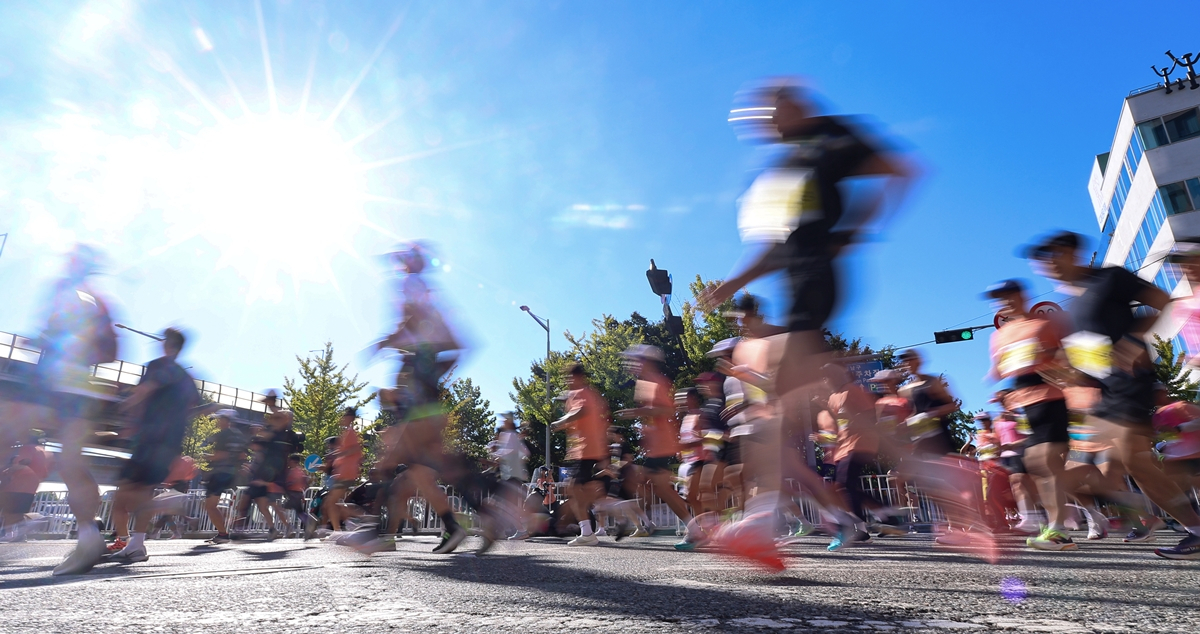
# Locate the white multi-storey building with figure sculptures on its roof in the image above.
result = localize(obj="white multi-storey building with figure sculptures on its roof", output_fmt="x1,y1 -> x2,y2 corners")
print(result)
1087,75 -> 1200,354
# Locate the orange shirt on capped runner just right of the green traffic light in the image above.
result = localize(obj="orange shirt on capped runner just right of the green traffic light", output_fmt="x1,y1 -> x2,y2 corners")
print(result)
991,316 -> 1063,407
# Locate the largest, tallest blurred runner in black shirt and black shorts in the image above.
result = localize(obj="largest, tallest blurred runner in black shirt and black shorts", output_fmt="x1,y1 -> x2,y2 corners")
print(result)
700,80 -> 910,569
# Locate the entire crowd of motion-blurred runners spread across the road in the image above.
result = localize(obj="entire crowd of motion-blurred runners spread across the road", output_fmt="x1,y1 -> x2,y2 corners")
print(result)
0,75 -> 1200,575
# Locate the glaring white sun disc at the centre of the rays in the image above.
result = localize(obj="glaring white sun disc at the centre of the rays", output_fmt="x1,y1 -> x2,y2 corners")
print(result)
173,116 -> 365,300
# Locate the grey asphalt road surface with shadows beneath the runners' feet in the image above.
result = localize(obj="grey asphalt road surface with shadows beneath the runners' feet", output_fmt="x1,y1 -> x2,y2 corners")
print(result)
0,532 -> 1200,634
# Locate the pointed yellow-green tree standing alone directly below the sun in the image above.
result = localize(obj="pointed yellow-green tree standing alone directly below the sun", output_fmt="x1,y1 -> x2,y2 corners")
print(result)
283,341 -> 374,455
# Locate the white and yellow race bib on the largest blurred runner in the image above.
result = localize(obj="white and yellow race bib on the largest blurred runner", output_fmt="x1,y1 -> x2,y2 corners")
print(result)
738,168 -> 822,243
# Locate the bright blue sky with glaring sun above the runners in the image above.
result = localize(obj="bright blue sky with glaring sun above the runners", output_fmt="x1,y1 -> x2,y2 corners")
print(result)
0,0 -> 1200,417
